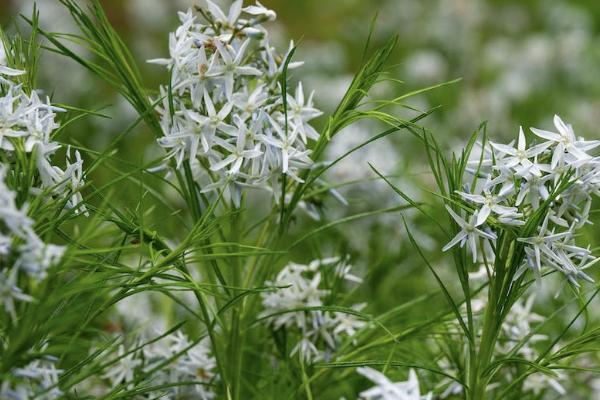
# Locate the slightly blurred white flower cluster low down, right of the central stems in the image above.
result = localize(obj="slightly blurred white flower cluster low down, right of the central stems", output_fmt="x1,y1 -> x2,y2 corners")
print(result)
262,257 -> 366,361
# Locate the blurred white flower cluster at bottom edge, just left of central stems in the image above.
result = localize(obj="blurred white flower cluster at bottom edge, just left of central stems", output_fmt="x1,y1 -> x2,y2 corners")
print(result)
102,331 -> 218,400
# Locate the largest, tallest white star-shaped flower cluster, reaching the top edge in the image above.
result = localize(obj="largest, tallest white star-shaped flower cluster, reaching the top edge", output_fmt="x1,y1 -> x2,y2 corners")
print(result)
149,0 -> 321,203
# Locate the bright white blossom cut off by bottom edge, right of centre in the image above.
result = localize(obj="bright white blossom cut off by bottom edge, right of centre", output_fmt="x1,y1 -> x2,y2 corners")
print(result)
356,367 -> 432,400
